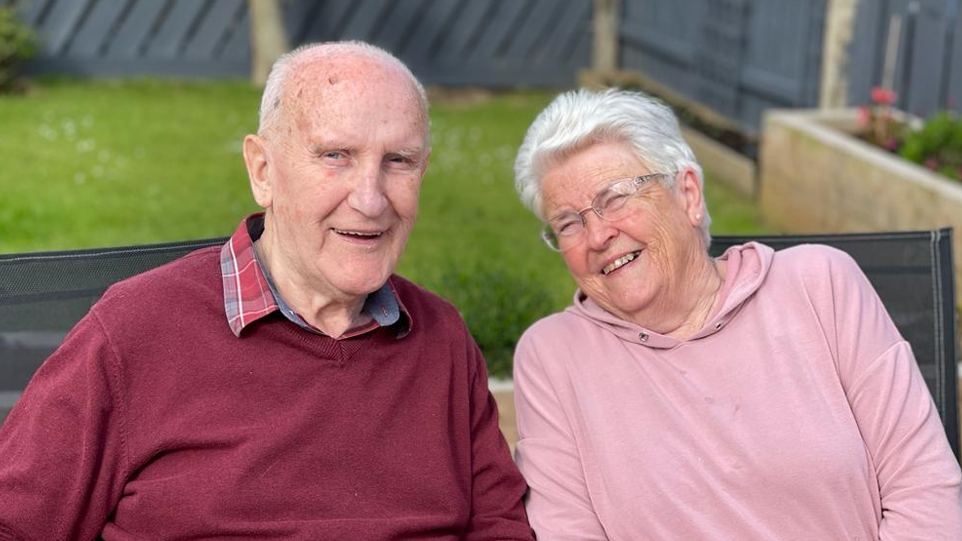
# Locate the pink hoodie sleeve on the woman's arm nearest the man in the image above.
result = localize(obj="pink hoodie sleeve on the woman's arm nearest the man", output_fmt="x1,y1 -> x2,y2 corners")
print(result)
514,330 -> 607,541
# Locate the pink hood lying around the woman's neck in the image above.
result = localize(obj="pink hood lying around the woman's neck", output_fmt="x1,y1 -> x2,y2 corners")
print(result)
565,242 -> 775,349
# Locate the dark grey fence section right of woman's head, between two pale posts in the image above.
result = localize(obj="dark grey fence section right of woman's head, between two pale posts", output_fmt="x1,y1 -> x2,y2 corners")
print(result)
619,0 -> 820,131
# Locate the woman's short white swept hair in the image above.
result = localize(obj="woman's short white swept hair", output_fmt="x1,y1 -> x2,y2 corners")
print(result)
514,89 -> 711,247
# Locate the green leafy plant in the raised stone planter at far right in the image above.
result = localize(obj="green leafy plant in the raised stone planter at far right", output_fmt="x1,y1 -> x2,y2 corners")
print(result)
899,112 -> 962,180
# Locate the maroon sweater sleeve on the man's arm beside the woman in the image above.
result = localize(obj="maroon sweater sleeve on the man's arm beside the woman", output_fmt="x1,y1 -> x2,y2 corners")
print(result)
463,336 -> 534,541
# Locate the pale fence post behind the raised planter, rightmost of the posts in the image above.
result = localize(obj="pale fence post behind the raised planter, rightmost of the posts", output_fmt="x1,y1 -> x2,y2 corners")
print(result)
818,0 -> 856,109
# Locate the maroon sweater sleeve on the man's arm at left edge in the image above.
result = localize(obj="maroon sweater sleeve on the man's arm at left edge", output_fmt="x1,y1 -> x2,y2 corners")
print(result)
0,315 -> 126,541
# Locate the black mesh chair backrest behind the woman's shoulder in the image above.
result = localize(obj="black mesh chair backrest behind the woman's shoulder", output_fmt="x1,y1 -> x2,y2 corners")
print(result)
711,229 -> 960,458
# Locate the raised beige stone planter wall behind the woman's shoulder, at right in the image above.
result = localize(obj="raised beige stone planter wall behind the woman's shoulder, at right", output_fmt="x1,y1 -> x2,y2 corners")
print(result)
759,109 -> 962,304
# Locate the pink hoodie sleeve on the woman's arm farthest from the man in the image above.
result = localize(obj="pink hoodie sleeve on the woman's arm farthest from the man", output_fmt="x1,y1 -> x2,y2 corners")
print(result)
831,249 -> 962,541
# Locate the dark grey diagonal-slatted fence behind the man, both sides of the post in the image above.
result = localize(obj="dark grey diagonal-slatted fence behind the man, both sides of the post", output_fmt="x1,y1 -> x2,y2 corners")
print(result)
7,0 -> 592,87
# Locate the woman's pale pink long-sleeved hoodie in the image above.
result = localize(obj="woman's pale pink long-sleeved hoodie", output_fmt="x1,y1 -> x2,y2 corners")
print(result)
514,243 -> 962,541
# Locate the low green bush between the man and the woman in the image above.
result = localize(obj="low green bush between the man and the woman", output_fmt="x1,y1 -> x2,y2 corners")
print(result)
429,259 -> 554,378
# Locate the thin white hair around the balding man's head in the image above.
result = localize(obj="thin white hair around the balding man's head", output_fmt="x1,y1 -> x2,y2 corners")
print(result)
257,41 -> 428,141
